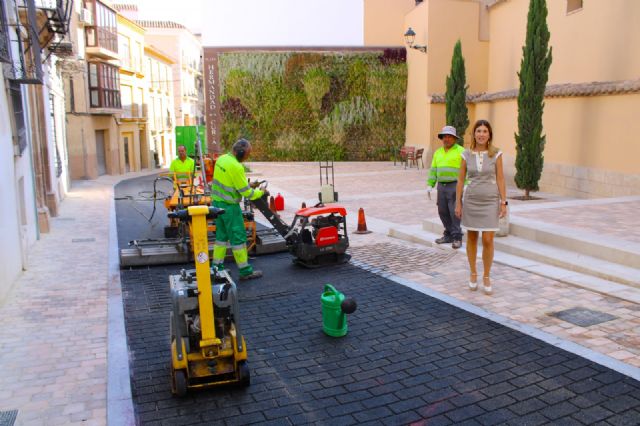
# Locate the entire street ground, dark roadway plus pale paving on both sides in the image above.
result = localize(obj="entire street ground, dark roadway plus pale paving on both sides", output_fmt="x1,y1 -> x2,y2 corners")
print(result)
0,163 -> 640,425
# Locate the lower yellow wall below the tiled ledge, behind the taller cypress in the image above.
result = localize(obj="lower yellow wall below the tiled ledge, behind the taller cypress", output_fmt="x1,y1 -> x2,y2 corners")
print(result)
475,94 -> 640,198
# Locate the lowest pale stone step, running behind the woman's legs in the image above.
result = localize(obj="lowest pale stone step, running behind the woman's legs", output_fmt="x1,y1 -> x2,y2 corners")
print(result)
388,225 -> 640,303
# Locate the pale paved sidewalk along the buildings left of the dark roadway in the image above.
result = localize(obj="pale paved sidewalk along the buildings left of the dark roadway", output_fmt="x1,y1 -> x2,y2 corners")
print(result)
0,180 -> 113,425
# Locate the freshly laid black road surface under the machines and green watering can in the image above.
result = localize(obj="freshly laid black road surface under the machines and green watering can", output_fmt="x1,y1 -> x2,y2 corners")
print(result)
116,178 -> 640,425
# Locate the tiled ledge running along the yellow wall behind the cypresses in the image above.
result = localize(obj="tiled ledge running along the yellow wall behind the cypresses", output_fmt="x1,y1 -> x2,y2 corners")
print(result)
431,79 -> 640,104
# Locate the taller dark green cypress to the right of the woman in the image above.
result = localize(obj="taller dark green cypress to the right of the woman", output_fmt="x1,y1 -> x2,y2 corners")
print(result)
515,0 -> 551,199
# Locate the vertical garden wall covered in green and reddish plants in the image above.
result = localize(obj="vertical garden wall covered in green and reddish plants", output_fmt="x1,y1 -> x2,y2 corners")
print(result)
219,49 -> 407,161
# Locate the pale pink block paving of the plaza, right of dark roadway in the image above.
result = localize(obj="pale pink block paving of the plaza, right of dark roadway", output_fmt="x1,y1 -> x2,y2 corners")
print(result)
252,162 -> 640,367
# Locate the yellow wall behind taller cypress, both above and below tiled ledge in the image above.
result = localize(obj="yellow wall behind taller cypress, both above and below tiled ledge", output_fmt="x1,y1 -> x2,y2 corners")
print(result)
480,0 -> 640,197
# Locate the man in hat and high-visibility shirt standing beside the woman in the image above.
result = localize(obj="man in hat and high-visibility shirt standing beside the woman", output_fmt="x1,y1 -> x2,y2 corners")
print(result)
427,126 -> 464,249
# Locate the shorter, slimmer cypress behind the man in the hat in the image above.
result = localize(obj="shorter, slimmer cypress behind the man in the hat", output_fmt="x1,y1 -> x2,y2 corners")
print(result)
444,40 -> 469,146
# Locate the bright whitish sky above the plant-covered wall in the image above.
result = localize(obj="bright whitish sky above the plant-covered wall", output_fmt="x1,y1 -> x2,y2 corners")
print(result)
135,0 -> 364,46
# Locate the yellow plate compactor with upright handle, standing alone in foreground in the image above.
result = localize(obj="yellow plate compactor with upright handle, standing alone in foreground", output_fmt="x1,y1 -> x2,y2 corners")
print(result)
169,206 -> 250,396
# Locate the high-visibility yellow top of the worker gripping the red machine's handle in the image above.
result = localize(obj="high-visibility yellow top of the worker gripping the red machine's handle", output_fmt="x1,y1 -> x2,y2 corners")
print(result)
211,154 -> 263,204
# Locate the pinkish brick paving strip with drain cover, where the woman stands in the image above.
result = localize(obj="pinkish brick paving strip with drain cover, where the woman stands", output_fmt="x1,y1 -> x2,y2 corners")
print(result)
352,243 -> 640,367
